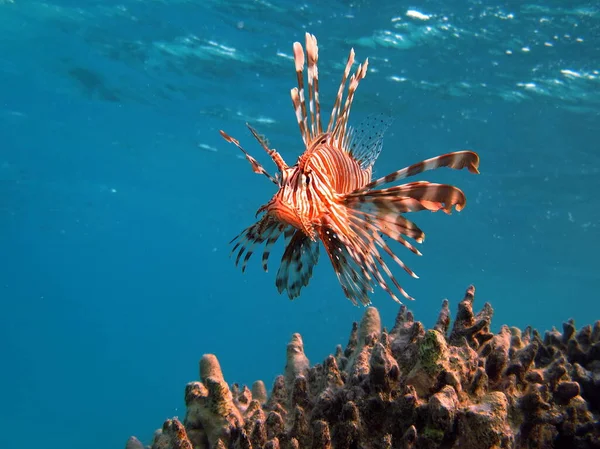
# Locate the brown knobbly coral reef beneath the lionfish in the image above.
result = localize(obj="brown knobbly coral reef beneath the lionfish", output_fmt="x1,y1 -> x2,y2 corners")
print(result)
127,287 -> 600,449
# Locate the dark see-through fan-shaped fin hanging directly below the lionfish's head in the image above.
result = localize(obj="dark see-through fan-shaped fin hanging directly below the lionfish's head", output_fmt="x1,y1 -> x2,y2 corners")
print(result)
275,230 -> 319,299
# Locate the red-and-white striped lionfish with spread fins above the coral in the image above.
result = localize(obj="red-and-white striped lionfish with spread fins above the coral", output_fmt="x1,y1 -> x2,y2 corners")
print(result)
220,33 -> 479,305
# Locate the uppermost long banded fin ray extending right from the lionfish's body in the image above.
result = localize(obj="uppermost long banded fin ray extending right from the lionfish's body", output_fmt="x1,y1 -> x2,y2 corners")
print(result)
356,151 -> 479,193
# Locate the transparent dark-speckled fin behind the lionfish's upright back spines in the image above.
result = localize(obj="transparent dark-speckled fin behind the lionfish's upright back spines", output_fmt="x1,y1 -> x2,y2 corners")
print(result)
344,114 -> 394,170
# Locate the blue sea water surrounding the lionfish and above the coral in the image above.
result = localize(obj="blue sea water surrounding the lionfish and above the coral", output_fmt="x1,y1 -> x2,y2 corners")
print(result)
0,0 -> 600,449
